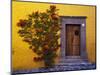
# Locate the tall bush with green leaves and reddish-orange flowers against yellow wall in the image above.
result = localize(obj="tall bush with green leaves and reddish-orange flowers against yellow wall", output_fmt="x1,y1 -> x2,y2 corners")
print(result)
17,5 -> 61,67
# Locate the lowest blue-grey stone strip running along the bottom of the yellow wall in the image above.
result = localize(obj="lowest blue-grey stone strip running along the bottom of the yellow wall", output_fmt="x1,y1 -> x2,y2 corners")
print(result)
12,63 -> 96,75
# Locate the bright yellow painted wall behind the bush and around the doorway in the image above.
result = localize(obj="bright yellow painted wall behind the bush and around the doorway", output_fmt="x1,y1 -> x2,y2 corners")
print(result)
12,1 -> 95,70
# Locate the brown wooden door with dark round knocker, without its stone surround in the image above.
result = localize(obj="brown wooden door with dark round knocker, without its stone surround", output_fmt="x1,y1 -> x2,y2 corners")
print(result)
66,24 -> 80,56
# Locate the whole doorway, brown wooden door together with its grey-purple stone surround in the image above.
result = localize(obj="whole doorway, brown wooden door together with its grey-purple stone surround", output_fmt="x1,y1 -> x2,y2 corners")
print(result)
60,16 -> 87,60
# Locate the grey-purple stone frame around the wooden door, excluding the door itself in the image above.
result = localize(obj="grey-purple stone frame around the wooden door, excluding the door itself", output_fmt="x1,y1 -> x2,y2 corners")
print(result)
60,16 -> 87,59
